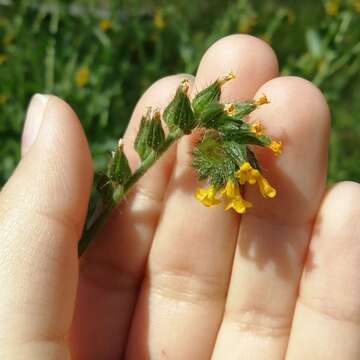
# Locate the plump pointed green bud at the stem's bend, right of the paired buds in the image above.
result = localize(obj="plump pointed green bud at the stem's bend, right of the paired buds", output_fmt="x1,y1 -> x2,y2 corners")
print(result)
163,80 -> 196,134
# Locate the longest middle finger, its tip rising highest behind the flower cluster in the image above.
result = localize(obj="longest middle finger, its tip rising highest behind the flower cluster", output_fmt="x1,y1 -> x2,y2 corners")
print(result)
127,35 -> 277,359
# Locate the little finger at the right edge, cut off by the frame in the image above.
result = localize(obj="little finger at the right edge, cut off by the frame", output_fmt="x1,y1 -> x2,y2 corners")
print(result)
286,182 -> 360,360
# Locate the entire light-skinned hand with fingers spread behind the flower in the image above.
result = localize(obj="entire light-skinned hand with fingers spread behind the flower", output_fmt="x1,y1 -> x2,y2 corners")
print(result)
0,35 -> 360,360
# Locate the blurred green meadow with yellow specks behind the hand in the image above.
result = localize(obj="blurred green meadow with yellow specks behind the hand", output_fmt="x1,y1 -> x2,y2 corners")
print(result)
0,0 -> 360,186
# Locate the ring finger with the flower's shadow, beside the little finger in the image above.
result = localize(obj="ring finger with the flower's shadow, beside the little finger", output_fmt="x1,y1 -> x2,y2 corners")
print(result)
214,77 -> 329,359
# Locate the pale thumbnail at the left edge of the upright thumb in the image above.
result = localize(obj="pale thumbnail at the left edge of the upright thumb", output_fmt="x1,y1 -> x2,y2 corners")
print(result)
21,94 -> 49,156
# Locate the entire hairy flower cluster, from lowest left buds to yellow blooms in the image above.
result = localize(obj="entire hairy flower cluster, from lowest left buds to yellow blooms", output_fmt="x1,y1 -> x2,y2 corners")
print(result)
98,73 -> 281,214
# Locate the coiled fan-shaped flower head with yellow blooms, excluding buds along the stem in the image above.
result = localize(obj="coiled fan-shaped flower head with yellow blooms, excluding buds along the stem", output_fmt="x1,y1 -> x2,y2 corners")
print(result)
192,74 -> 281,214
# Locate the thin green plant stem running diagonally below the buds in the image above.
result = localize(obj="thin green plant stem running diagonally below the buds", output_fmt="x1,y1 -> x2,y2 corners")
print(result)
78,129 -> 184,257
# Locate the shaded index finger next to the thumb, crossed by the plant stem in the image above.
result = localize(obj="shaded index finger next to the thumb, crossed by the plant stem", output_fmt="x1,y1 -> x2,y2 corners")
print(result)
71,74 -> 192,360
